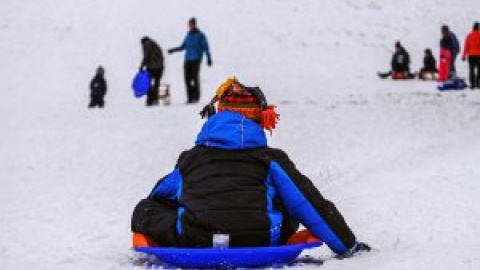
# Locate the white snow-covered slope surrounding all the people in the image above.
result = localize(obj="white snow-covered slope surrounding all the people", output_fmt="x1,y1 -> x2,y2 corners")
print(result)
0,0 -> 480,270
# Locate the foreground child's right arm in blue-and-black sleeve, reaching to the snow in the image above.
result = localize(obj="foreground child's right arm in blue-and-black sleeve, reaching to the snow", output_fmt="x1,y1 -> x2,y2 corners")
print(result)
269,150 -> 357,255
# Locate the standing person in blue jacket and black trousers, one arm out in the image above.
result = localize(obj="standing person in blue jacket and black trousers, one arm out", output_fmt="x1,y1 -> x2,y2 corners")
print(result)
168,18 -> 212,103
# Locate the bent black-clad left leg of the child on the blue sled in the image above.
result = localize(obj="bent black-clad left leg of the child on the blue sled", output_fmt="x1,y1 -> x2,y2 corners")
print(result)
131,199 -> 179,247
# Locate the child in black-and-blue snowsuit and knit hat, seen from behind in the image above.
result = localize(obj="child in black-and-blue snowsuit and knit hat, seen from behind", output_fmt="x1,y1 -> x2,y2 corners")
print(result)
131,77 -> 370,257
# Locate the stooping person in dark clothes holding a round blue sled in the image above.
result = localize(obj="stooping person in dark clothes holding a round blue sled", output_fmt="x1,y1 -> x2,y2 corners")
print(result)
139,37 -> 164,106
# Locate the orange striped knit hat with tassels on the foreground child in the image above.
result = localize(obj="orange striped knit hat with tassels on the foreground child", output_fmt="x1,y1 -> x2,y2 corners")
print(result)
200,77 -> 279,132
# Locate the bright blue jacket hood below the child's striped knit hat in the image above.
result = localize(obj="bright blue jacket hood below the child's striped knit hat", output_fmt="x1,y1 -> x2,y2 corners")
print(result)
195,111 -> 267,150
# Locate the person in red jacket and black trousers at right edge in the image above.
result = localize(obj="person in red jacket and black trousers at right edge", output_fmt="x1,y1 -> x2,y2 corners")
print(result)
462,22 -> 480,90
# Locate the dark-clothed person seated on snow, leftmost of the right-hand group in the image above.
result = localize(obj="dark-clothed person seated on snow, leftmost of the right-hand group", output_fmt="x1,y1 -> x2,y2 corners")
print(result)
378,41 -> 415,79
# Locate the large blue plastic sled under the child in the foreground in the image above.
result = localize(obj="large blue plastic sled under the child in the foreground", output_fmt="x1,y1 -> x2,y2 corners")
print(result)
135,241 -> 323,268
